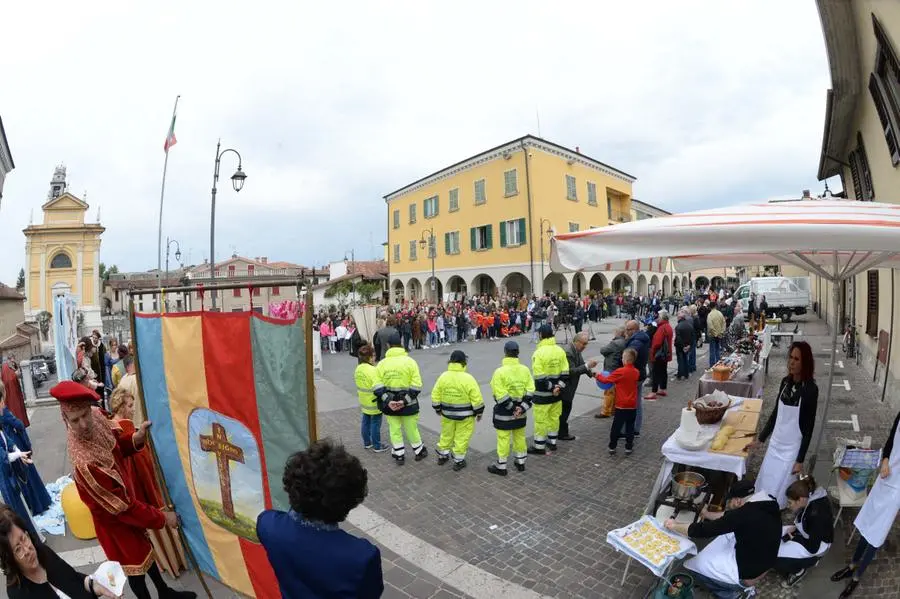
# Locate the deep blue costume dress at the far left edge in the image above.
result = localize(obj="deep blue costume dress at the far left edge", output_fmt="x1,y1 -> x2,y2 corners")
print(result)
0,408 -> 51,533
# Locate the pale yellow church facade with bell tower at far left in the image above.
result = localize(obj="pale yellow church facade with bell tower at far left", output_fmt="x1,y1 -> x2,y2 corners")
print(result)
24,166 -> 105,331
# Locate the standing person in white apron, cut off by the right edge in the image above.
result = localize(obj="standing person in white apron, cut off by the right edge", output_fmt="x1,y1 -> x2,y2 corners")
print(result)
831,414 -> 900,599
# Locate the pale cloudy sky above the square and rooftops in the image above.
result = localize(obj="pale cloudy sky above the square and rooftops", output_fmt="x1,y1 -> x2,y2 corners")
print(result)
0,0 -> 839,284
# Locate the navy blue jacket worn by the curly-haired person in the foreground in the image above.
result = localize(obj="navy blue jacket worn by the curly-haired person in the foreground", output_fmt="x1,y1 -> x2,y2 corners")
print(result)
256,510 -> 384,599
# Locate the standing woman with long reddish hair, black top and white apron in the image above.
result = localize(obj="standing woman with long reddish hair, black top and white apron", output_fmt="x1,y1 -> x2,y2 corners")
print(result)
748,341 -> 819,509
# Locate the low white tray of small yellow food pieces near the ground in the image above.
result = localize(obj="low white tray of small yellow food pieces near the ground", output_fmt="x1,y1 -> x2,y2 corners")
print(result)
606,516 -> 697,576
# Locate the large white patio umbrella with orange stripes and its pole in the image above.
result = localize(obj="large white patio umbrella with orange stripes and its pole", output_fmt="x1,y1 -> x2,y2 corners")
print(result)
550,199 -> 900,467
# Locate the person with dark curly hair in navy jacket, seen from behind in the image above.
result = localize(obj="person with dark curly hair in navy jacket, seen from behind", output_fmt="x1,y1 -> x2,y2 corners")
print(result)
256,439 -> 384,599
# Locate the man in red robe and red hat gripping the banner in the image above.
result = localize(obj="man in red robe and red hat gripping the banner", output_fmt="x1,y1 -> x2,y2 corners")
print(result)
50,381 -> 197,599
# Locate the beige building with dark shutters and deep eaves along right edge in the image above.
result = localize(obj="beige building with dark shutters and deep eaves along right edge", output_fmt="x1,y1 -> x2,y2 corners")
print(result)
812,0 -> 900,403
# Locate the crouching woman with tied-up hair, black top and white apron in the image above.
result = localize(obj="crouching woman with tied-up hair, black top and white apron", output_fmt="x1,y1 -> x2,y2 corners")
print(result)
775,475 -> 834,588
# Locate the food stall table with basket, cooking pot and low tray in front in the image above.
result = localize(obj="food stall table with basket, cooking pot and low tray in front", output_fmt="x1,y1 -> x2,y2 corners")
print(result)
607,391 -> 762,596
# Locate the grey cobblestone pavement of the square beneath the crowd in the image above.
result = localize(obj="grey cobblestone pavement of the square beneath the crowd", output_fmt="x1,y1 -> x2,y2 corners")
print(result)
319,317 -> 900,598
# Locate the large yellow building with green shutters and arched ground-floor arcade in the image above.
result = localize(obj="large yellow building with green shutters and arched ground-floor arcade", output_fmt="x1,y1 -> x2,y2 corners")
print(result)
384,135 -> 670,302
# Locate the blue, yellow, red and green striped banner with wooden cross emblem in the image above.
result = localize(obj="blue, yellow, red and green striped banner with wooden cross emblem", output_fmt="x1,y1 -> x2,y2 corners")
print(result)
135,312 -> 315,599
